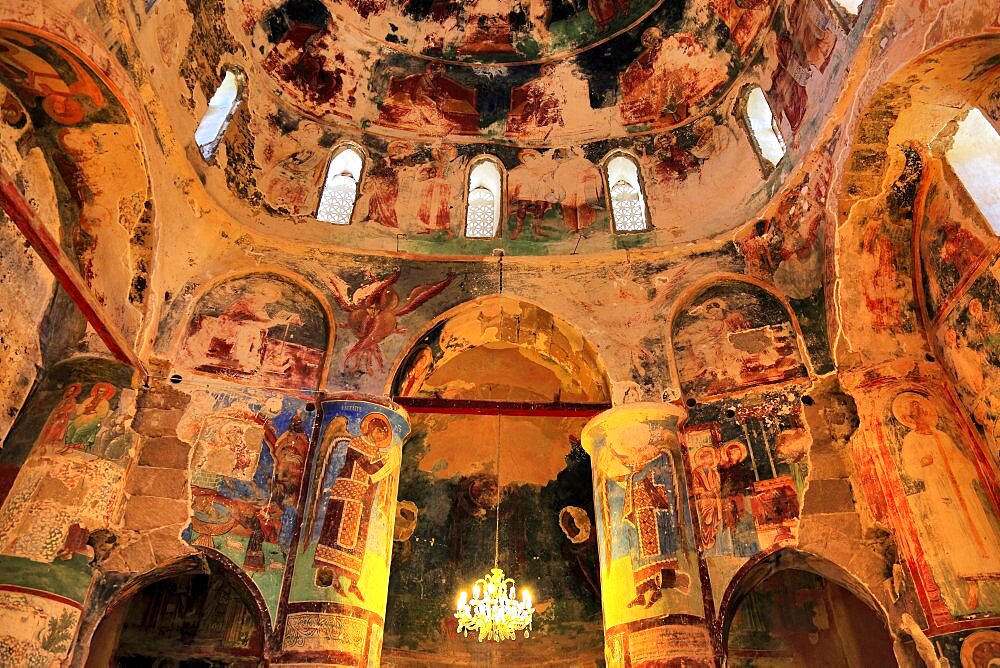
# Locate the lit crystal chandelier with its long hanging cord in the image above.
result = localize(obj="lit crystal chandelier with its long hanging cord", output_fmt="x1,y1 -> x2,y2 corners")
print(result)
455,413 -> 535,642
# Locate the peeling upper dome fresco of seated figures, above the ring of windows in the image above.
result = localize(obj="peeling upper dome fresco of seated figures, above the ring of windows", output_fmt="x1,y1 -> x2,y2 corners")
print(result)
244,0 -> 772,143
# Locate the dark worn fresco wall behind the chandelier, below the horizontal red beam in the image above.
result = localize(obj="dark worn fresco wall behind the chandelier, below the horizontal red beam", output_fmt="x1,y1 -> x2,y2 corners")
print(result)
384,413 -> 603,666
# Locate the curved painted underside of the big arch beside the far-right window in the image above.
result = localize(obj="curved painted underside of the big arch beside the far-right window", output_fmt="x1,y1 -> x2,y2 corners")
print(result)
835,35 -> 1000,366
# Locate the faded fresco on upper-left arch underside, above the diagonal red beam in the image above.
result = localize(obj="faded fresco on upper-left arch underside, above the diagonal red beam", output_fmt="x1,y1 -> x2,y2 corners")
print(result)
0,28 -> 154,336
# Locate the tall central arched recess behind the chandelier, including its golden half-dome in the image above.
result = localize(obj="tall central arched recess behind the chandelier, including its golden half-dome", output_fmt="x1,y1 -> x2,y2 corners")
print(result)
383,295 -> 610,665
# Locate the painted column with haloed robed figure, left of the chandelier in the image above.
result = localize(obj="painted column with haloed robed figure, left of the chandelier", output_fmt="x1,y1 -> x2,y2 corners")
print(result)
274,395 -> 410,666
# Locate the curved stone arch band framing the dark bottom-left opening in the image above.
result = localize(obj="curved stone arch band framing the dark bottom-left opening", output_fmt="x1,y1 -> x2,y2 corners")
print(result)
82,547 -> 277,666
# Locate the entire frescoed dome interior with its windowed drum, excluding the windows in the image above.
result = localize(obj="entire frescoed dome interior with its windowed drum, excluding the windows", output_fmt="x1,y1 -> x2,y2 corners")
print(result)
137,0 -> 867,256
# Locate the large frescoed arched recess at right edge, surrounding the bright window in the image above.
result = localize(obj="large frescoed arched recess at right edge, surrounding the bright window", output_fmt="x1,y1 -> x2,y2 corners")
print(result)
830,34 -> 1000,470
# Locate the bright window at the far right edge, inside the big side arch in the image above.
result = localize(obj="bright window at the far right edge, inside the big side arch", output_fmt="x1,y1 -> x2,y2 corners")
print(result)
945,107 -> 1000,235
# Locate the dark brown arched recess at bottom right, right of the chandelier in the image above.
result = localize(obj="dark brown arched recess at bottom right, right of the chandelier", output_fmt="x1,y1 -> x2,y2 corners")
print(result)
718,548 -> 896,668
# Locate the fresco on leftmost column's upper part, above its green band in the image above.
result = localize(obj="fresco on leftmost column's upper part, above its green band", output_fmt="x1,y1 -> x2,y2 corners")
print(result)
0,358 -> 135,562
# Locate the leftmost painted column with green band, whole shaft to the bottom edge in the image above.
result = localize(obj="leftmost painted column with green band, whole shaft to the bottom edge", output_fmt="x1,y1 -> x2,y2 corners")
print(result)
0,357 -> 136,666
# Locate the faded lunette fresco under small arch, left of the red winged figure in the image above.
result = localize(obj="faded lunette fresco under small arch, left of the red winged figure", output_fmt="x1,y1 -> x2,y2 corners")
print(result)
171,266 -> 336,390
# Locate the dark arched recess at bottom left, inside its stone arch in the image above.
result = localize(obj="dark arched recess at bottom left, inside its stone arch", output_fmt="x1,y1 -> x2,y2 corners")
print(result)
84,548 -> 276,668
